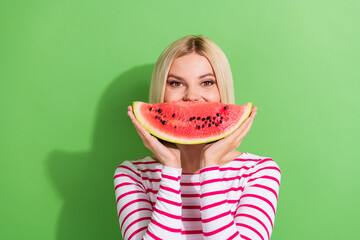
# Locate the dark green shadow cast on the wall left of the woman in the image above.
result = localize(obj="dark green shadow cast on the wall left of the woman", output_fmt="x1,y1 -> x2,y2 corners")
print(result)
46,64 -> 155,240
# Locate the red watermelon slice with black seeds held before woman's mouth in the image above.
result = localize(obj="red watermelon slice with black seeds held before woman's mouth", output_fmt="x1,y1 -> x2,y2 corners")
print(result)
133,101 -> 253,144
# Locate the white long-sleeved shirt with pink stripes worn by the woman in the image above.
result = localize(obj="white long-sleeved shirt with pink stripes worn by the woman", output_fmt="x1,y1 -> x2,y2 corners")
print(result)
114,152 -> 281,240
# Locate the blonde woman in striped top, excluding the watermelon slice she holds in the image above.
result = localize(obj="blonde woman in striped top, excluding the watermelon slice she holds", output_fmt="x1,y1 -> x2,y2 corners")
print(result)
114,35 -> 280,240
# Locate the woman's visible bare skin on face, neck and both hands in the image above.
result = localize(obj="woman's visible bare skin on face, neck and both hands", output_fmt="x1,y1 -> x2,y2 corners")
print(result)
128,53 -> 257,173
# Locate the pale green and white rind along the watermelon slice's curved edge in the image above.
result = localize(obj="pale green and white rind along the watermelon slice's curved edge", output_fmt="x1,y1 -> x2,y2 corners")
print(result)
133,101 -> 253,144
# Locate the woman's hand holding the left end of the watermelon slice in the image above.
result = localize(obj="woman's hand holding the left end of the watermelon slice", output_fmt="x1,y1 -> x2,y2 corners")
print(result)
128,106 -> 181,168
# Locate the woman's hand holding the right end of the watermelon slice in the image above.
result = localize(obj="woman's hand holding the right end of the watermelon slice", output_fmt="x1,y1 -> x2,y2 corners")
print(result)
200,106 -> 257,168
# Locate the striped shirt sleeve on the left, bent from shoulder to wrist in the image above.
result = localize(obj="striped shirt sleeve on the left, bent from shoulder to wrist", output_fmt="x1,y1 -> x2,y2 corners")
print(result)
114,161 -> 182,240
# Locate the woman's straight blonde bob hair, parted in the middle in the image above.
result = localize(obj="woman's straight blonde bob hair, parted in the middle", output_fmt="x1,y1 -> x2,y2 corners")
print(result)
149,34 -> 235,104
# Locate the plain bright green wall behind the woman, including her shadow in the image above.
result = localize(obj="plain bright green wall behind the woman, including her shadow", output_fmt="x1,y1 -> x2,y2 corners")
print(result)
0,0 -> 360,240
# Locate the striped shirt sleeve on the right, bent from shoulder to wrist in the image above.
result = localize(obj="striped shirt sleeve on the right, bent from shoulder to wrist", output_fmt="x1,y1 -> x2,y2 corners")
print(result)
200,159 -> 280,240
